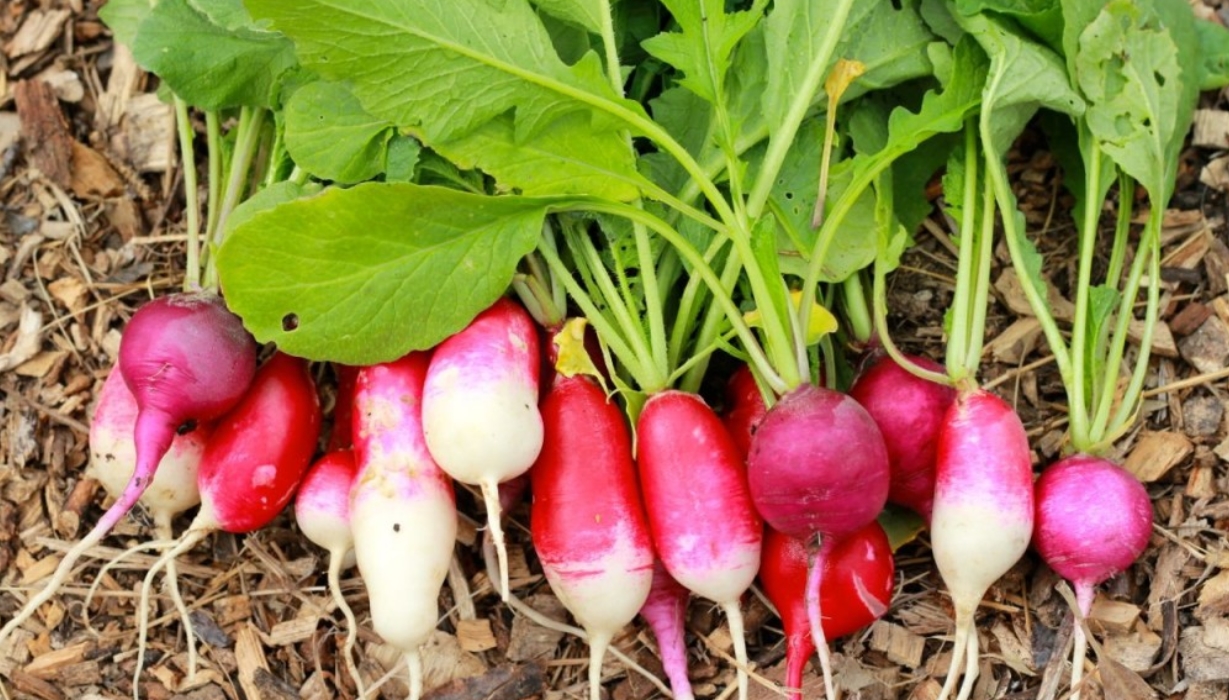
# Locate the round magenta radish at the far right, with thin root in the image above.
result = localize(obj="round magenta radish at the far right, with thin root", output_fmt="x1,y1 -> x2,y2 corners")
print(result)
1032,454 -> 1153,700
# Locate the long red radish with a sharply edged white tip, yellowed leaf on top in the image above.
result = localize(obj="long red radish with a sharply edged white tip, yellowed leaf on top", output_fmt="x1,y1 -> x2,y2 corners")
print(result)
530,375 -> 653,700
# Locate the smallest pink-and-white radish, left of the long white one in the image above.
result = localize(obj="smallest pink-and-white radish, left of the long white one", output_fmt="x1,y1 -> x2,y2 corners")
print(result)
295,449 -> 365,698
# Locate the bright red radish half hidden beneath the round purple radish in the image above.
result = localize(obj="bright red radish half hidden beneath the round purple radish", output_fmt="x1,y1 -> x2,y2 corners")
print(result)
760,521 -> 896,700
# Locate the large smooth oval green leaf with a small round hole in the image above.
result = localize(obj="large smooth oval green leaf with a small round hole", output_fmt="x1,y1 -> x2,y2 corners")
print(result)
218,183 -> 549,365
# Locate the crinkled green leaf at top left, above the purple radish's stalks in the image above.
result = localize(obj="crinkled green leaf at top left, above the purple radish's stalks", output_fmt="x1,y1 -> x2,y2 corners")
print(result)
133,0 -> 295,109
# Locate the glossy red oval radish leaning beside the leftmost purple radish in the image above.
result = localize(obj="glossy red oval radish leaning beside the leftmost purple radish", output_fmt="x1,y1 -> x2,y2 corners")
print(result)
133,352 -> 321,696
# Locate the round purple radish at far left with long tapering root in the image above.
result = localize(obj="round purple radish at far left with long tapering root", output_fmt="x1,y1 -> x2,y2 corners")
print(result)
0,292 -> 256,641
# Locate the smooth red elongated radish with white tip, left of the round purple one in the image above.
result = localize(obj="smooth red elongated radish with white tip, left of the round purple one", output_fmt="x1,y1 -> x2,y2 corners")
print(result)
637,391 -> 763,698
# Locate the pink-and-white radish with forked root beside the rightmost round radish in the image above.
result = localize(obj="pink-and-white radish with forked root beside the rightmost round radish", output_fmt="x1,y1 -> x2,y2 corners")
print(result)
930,389 -> 1034,700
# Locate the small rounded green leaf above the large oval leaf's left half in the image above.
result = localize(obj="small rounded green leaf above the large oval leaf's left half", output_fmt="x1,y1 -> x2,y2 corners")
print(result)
284,80 -> 393,184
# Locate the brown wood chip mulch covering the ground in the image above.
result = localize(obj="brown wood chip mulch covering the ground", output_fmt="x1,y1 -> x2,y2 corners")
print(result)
0,0 -> 1229,700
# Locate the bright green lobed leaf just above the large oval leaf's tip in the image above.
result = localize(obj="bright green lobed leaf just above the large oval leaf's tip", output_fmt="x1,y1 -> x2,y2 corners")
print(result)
435,113 -> 648,201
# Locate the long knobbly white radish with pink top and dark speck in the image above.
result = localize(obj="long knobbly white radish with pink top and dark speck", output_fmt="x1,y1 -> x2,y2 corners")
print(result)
350,352 -> 457,700
